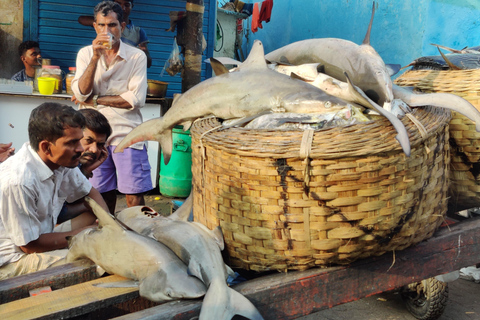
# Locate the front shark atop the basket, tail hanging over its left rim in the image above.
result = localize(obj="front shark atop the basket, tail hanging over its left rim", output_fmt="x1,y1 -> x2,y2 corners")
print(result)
115,40 -> 358,164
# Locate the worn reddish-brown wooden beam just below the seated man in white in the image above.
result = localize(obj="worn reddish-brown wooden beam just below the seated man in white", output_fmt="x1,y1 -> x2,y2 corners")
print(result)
0,260 -> 98,304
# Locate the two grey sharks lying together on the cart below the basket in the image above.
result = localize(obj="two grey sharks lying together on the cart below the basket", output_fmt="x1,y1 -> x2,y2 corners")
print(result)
66,196 -> 263,320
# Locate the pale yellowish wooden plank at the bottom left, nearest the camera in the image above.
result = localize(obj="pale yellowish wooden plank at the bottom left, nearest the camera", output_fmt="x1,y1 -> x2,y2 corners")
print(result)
0,275 -> 138,319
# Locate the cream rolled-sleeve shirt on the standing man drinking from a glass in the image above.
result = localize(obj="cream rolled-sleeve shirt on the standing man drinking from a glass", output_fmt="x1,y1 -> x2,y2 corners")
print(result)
72,41 -> 148,149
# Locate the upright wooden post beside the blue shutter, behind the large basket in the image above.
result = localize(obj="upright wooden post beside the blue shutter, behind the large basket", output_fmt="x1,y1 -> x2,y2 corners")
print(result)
182,0 -> 205,92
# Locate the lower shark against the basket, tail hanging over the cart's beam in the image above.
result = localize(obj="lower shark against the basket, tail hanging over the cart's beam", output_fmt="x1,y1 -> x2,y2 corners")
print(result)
117,195 -> 263,320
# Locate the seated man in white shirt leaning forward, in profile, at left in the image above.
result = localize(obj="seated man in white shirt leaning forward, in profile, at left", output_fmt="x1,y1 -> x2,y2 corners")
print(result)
0,103 -> 108,280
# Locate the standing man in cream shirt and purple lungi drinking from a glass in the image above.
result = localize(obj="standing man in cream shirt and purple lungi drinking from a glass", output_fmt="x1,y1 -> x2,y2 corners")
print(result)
72,1 -> 153,213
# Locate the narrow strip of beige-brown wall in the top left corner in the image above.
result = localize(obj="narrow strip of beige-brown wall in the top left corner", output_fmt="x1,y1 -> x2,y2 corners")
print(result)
0,0 -> 23,79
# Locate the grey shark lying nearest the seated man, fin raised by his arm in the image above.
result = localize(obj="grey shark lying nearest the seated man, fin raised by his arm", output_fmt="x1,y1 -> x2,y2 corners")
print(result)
66,197 -> 206,302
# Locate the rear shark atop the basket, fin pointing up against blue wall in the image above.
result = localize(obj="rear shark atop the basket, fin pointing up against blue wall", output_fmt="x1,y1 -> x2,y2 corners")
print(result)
265,3 -> 393,107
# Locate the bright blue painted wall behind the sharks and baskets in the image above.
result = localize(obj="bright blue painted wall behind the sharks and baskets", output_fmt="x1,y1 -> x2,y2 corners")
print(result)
243,0 -> 480,77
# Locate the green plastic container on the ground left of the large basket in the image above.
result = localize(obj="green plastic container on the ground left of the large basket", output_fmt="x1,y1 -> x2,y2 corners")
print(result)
159,126 -> 192,198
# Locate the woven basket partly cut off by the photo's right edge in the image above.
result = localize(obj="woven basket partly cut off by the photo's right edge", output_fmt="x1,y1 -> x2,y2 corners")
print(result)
395,69 -> 480,212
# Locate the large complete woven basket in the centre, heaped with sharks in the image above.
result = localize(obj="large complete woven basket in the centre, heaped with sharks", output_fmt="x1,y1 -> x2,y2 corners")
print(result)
191,107 -> 450,271
